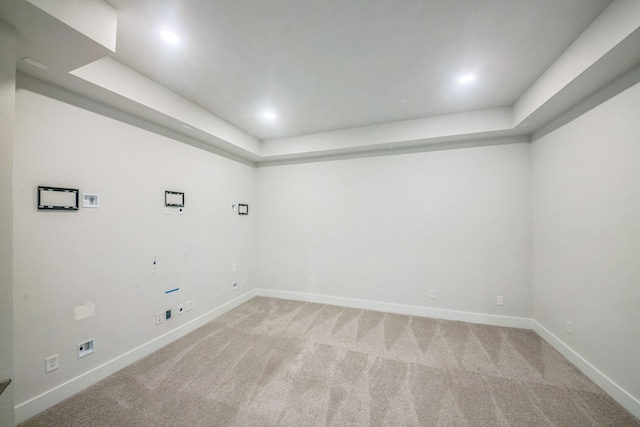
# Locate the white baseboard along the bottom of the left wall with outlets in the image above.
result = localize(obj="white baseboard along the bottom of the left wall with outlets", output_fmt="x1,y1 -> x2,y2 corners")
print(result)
15,290 -> 256,424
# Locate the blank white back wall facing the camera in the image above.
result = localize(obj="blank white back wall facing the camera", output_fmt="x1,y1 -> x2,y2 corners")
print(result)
258,143 -> 531,318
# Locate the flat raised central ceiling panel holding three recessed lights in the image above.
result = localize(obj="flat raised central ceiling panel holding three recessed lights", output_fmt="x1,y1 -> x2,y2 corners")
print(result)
109,0 -> 611,140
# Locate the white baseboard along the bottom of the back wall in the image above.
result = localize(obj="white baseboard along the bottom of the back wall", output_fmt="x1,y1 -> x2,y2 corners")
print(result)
256,289 -> 532,329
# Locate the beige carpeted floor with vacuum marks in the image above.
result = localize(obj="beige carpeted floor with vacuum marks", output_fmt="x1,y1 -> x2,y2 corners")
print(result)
21,298 -> 640,427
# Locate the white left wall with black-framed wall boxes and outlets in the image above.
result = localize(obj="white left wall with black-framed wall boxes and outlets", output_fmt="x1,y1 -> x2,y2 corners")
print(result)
14,88 -> 256,407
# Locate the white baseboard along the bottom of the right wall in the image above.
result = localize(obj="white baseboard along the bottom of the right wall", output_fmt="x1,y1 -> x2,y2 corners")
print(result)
532,320 -> 640,419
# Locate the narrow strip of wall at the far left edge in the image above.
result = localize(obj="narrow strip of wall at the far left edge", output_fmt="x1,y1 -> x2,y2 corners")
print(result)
0,23 -> 16,426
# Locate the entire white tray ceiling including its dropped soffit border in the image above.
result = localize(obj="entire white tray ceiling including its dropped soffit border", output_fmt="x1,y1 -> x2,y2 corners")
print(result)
0,0 -> 640,164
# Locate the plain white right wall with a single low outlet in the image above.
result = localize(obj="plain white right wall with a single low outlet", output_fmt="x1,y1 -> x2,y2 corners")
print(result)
532,84 -> 640,408
